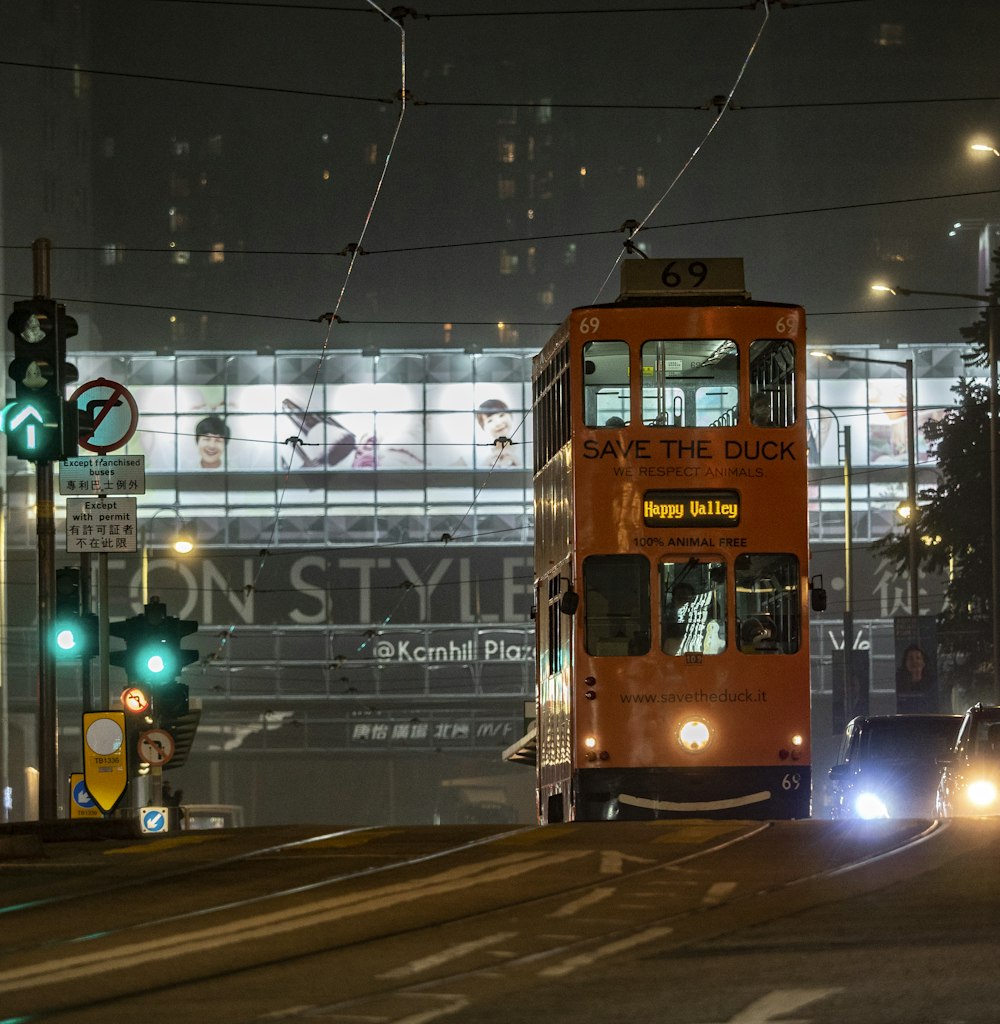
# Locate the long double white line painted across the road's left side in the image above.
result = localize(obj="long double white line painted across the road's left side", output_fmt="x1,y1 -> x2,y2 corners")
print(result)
0,850 -> 593,992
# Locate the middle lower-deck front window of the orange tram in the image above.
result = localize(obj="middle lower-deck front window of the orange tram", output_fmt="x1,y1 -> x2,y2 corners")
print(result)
659,558 -> 726,654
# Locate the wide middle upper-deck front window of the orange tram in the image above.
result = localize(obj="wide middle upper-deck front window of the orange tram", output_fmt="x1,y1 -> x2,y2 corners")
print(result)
642,338 -> 739,427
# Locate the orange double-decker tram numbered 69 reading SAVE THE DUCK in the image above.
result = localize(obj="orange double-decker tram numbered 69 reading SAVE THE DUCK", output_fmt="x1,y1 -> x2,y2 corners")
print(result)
532,259 -> 822,822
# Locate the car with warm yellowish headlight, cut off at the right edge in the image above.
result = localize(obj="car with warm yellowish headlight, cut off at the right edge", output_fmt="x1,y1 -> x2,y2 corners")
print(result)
937,703 -> 1000,818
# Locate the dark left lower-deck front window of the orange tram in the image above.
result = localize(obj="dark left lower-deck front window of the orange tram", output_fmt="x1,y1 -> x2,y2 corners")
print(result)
583,555 -> 650,657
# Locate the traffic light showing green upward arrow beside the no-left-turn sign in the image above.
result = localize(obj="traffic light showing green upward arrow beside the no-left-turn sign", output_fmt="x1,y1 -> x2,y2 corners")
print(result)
0,299 -> 79,462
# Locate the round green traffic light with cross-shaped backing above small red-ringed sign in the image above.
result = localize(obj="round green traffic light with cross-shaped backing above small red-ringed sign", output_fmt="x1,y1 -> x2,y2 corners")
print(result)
110,597 -> 200,688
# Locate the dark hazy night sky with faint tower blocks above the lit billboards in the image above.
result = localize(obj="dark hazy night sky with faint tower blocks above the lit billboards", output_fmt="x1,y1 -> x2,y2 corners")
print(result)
7,0 -> 1000,350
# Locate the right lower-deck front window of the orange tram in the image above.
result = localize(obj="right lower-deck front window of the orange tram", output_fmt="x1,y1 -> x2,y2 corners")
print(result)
735,554 -> 801,654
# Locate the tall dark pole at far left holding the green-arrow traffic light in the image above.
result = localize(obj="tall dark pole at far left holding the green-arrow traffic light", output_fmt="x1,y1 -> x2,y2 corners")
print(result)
32,239 -> 59,821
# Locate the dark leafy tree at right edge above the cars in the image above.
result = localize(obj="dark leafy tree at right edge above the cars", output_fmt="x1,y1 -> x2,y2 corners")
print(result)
873,249 -> 1000,702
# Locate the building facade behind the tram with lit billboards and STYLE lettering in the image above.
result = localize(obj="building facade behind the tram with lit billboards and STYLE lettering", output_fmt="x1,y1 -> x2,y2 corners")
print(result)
4,345 -> 982,822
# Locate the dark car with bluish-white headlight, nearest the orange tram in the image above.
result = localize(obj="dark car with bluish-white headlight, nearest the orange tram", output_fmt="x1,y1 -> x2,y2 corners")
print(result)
828,715 -> 962,819
